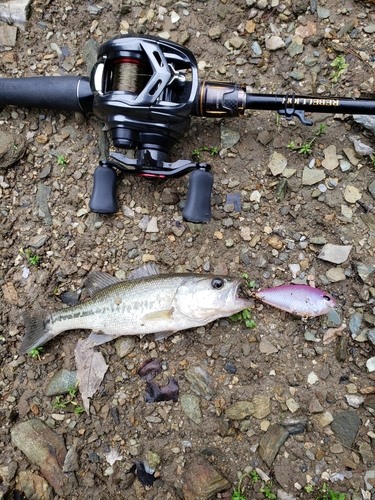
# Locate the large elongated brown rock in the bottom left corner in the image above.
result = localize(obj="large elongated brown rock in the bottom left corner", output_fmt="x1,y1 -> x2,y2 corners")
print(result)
11,419 -> 75,498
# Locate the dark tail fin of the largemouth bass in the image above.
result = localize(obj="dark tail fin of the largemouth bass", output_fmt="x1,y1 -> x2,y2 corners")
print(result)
20,312 -> 54,354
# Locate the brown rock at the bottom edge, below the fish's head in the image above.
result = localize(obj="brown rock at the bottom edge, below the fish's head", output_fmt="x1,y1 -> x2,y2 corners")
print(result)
182,455 -> 231,500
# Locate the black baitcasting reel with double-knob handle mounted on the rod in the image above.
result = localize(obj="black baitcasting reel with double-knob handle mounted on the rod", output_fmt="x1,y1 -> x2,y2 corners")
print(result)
90,35 -> 212,222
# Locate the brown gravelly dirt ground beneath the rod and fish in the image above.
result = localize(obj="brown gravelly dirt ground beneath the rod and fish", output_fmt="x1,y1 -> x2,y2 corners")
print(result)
0,0 -> 375,500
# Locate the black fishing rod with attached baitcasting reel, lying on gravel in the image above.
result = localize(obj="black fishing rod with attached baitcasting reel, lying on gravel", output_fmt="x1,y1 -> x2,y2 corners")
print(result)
0,35 -> 375,223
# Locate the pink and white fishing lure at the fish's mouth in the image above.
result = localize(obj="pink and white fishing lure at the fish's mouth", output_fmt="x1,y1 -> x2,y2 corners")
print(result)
254,285 -> 341,324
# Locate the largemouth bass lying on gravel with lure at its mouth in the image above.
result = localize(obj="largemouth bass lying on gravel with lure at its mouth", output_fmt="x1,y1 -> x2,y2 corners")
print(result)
20,264 -> 252,354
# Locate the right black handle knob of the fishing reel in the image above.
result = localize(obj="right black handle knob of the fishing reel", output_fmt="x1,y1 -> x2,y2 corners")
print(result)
182,167 -> 214,223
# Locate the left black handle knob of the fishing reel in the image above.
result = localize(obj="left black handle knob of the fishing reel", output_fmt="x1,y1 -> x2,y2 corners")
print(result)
89,162 -> 117,214
